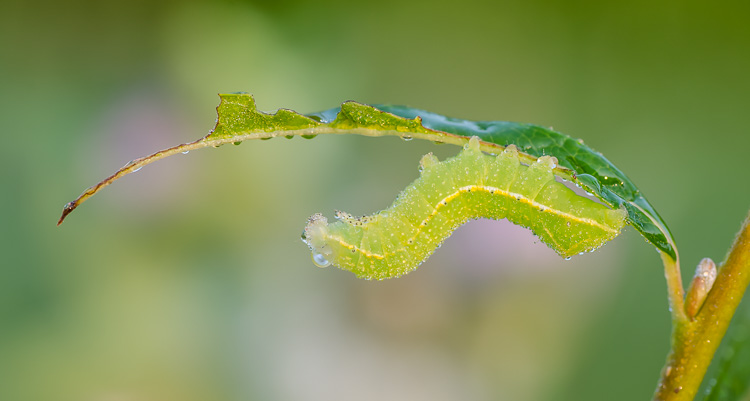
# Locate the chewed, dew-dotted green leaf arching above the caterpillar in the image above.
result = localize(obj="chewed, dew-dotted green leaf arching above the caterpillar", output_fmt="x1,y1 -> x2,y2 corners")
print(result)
58,93 -> 676,259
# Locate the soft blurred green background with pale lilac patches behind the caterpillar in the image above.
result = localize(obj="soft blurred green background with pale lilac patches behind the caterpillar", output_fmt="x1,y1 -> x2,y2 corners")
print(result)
0,0 -> 750,401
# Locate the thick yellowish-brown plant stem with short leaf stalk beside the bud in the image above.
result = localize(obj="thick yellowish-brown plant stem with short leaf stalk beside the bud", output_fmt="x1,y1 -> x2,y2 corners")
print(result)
654,209 -> 750,401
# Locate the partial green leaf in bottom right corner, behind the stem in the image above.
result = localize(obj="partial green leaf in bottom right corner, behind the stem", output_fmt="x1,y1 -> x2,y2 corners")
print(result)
704,302 -> 750,401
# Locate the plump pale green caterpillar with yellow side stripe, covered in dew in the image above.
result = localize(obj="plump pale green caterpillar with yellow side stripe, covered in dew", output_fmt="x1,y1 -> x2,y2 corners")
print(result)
302,137 -> 626,280
